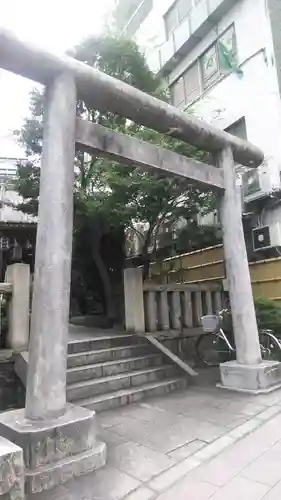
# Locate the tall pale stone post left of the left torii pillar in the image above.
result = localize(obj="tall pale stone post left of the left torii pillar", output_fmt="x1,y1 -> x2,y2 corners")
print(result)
5,264 -> 30,351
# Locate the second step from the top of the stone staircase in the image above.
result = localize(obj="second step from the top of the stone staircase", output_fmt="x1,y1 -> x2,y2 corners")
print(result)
67,343 -> 153,368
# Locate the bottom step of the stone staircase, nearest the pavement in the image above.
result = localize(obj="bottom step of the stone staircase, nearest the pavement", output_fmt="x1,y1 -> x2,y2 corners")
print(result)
76,377 -> 188,411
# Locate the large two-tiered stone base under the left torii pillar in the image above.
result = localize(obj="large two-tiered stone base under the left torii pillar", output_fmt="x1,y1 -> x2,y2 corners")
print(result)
0,404 -> 106,495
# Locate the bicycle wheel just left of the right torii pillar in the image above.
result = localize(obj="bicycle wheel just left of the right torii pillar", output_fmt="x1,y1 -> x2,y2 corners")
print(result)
195,333 -> 232,366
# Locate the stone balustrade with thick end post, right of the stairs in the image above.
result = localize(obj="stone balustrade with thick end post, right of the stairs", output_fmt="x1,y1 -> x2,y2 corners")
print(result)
124,268 -> 223,333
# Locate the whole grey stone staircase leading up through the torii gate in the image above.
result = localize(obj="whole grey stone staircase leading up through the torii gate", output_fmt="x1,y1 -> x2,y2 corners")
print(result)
67,334 -> 188,411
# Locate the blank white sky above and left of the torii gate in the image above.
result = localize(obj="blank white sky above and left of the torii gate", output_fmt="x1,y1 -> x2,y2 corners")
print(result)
0,0 -> 115,157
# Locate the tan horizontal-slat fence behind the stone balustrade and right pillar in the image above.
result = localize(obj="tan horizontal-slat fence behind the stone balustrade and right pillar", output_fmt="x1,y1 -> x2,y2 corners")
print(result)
150,245 -> 281,304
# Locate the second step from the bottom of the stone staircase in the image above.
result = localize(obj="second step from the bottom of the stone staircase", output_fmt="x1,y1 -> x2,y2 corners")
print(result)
66,365 -> 179,402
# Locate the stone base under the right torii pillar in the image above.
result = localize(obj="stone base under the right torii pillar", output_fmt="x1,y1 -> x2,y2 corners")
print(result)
217,361 -> 281,394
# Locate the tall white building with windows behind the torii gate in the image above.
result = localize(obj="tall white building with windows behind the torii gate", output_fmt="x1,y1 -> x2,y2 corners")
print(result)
116,0 -> 281,256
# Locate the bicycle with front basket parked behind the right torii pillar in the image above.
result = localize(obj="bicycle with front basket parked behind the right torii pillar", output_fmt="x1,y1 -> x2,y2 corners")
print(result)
195,310 -> 281,366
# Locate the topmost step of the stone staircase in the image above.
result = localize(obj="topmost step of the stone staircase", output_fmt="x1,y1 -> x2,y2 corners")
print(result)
68,333 -> 143,354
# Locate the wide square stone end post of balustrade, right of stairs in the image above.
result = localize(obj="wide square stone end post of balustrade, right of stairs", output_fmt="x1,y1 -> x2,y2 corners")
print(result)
124,268 -> 145,333
